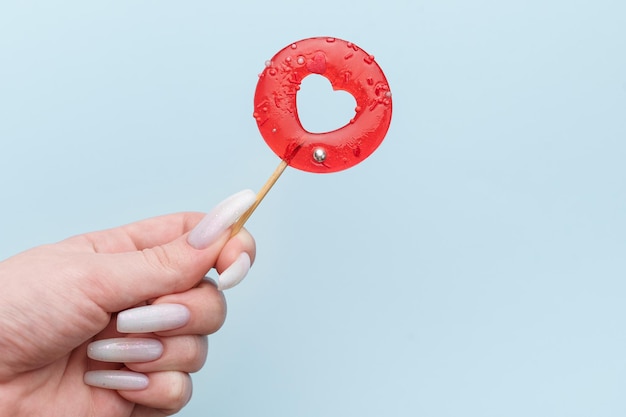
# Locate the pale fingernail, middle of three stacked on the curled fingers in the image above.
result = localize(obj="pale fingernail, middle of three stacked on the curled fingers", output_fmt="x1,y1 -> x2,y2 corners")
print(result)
87,337 -> 163,362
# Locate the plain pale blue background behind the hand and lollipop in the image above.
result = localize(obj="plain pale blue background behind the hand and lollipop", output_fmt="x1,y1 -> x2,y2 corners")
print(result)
0,0 -> 626,417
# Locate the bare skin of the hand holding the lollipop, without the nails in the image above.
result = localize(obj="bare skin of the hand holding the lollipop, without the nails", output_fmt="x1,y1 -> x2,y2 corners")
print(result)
0,213 -> 256,417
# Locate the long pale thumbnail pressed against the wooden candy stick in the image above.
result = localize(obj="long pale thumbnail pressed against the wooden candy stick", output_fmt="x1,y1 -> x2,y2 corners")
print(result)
187,190 -> 256,249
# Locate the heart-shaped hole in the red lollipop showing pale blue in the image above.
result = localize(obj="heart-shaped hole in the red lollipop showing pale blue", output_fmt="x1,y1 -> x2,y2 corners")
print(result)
296,74 -> 356,133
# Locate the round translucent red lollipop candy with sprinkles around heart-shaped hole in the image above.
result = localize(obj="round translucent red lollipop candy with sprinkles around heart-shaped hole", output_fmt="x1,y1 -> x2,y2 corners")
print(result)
253,38 -> 391,173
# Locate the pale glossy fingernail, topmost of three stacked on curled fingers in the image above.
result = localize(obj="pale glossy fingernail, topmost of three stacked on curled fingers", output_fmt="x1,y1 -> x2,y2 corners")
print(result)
117,304 -> 191,333
